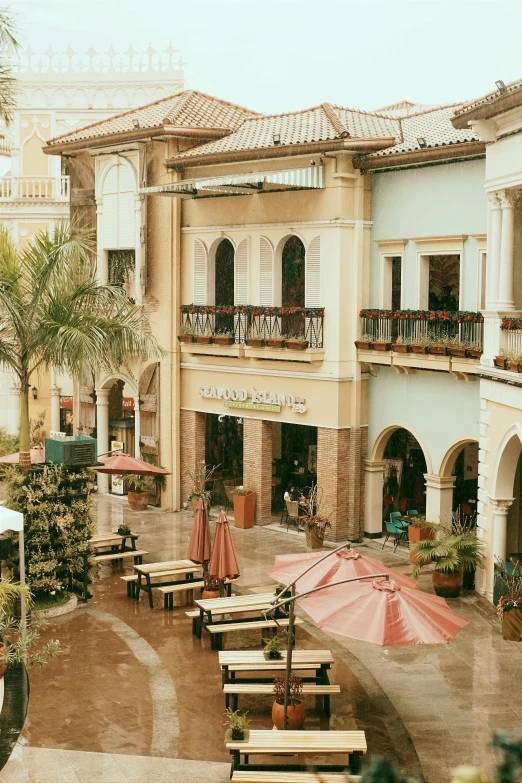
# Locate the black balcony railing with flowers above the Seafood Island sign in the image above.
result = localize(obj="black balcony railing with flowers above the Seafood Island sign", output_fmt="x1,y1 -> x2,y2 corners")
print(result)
180,305 -> 324,348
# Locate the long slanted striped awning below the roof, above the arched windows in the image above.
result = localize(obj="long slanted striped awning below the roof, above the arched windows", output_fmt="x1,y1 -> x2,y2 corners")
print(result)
140,166 -> 324,198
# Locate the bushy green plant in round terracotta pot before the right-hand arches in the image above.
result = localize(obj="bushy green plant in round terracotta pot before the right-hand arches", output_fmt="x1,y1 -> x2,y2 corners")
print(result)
410,527 -> 482,598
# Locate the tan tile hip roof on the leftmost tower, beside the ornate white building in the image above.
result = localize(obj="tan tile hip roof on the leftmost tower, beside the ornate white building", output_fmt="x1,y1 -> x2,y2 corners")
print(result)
48,90 -> 258,147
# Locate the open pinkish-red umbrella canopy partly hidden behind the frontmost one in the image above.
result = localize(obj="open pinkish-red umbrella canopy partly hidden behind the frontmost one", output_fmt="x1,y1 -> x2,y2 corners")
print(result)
269,549 -> 417,593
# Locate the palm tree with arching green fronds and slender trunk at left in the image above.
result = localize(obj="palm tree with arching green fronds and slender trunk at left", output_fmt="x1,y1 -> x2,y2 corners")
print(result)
0,222 -> 163,470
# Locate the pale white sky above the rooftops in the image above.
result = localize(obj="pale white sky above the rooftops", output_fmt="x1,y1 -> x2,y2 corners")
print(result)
10,0 -> 522,113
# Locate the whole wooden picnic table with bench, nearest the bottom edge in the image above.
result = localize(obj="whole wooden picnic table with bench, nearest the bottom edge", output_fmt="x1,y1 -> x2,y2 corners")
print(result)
226,730 -> 366,777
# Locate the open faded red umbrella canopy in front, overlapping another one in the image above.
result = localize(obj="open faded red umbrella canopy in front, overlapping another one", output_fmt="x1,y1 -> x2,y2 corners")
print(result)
301,579 -> 470,646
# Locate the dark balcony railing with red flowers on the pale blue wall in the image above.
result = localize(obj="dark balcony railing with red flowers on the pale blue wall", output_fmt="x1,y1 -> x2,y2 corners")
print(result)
360,310 -> 482,350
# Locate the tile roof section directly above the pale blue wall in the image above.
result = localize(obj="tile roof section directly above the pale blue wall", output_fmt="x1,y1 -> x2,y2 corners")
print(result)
367,104 -> 478,158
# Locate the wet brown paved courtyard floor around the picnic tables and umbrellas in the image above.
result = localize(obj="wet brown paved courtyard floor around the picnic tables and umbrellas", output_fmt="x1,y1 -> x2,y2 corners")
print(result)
0,497 -> 522,783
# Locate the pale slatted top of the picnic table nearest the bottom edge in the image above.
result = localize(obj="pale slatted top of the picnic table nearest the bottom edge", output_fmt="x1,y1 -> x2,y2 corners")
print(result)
225,730 -> 366,755
